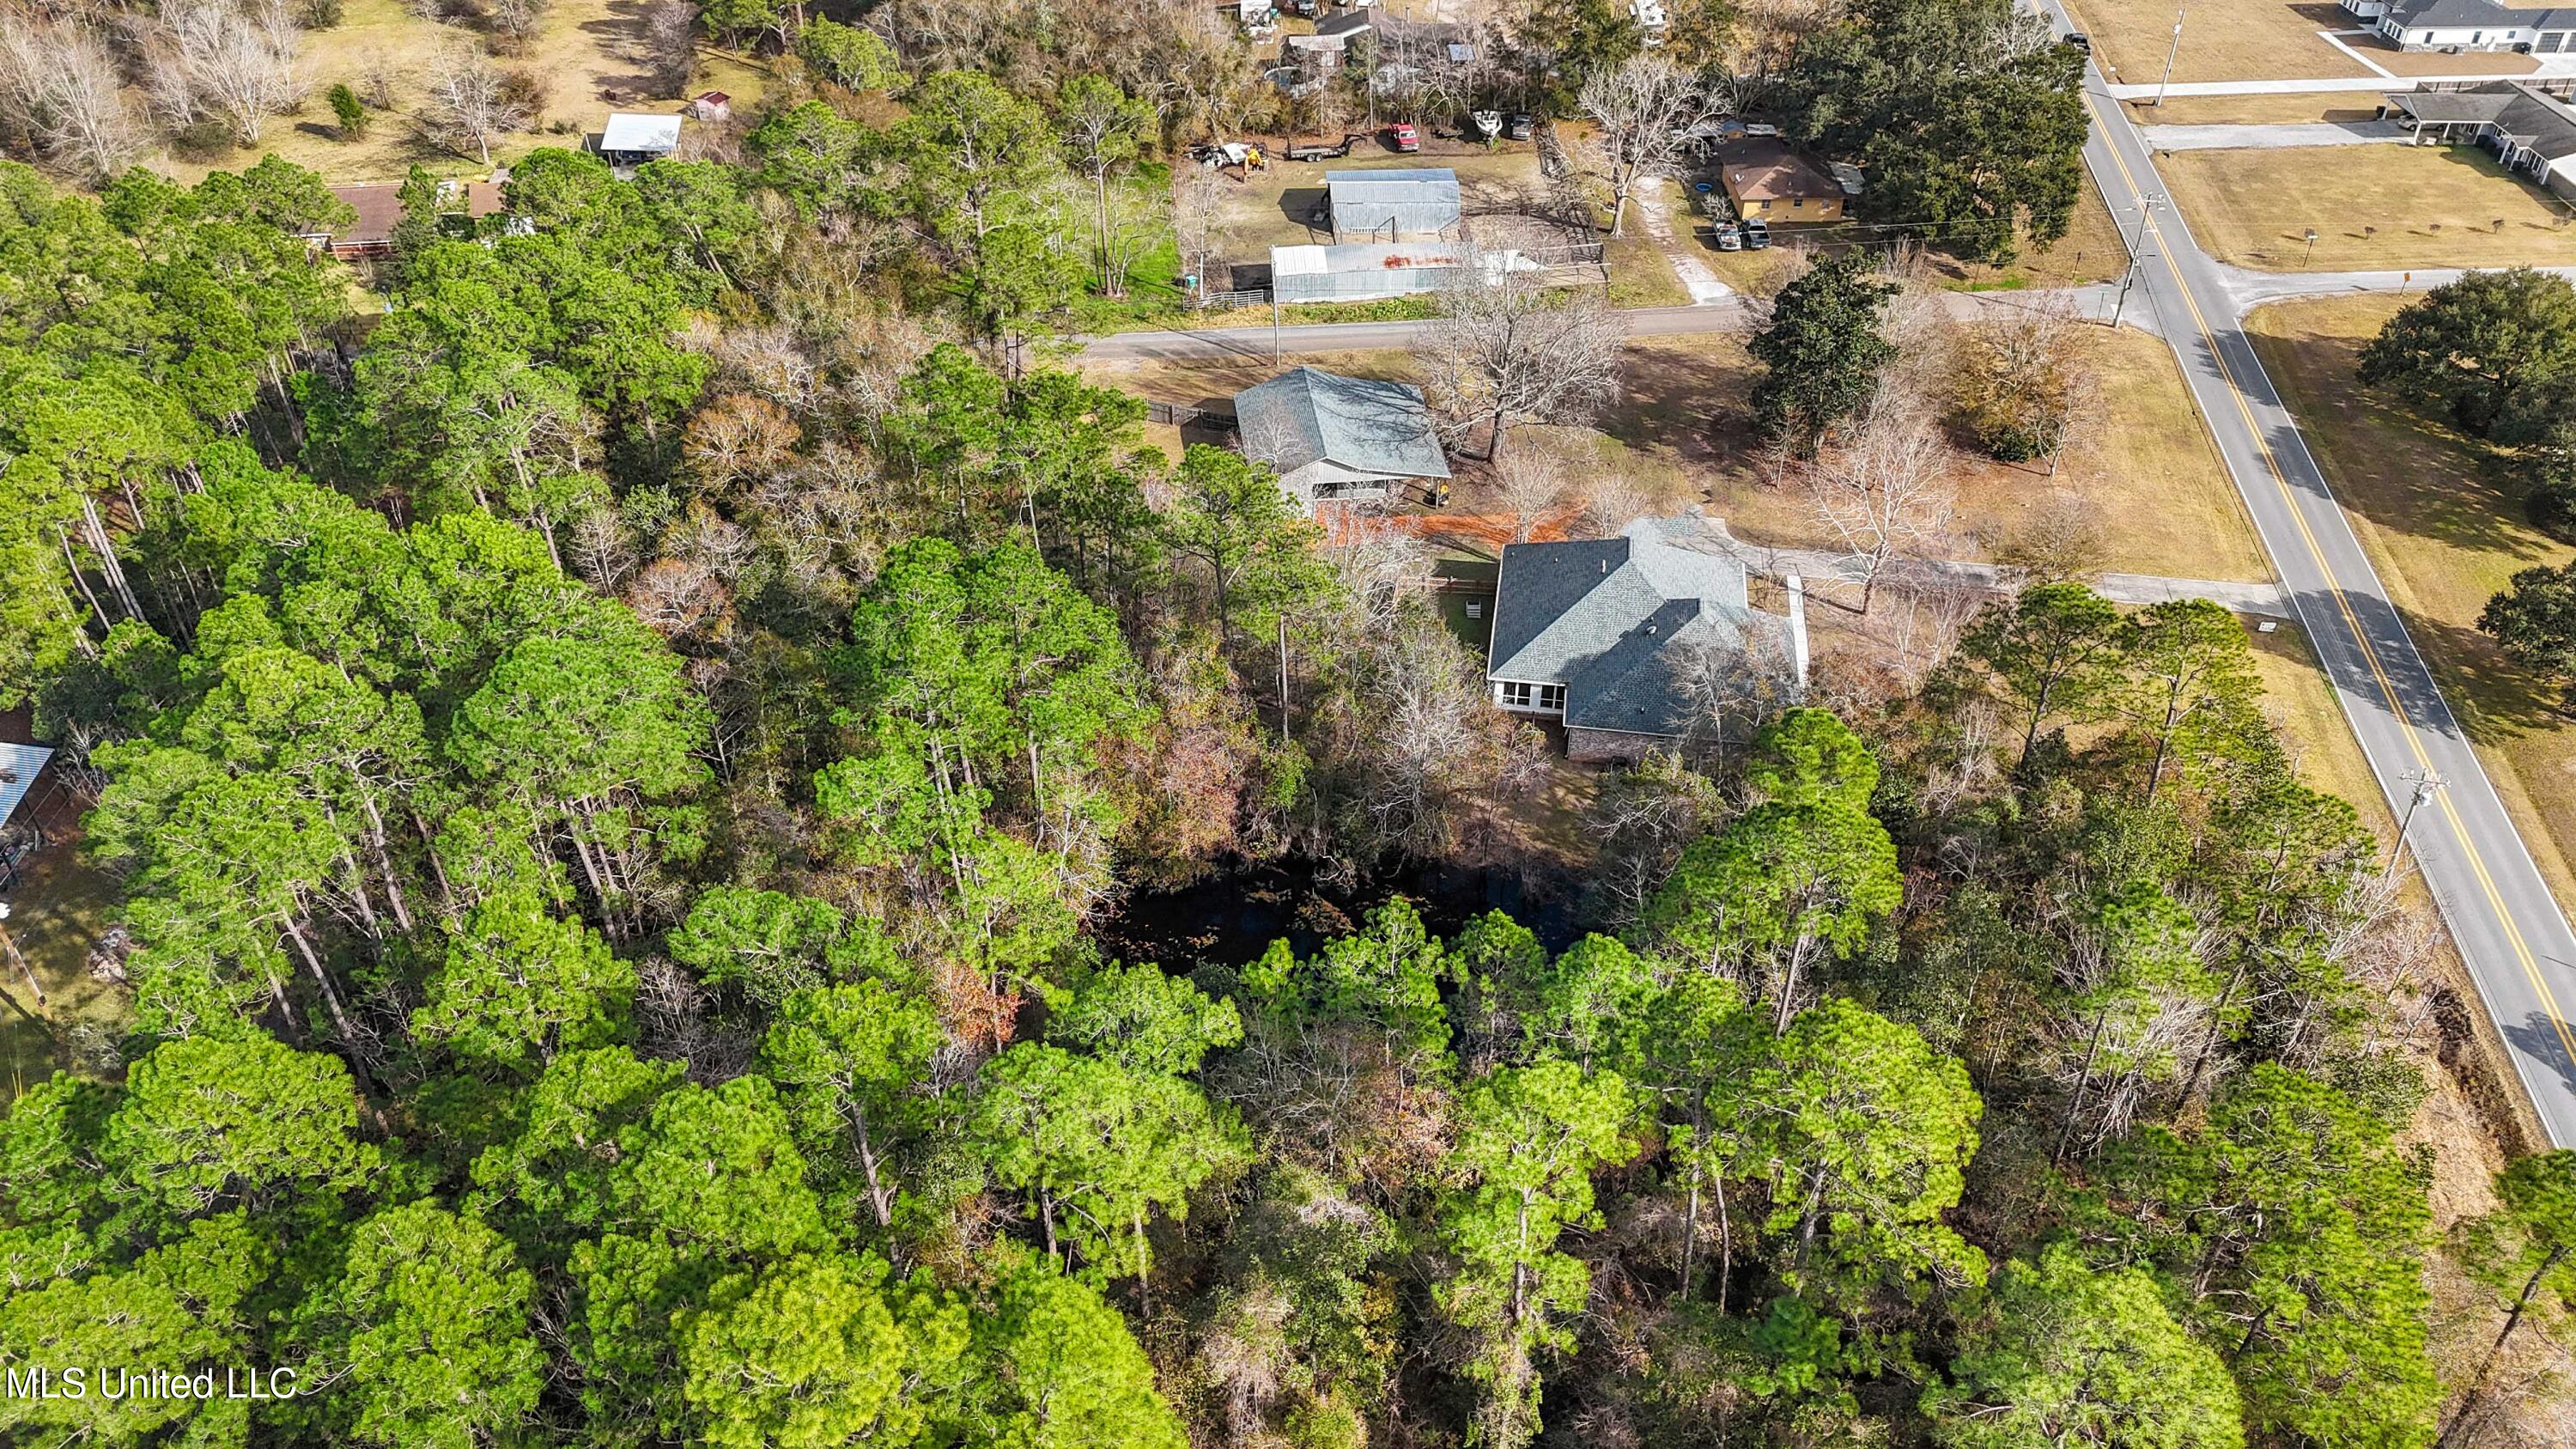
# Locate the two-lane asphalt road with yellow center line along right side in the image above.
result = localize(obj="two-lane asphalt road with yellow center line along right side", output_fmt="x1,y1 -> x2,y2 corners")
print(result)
2058,27 -> 2576,1148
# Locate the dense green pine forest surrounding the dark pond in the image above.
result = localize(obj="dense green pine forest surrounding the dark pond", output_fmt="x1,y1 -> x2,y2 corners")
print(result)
0,8 -> 2576,1449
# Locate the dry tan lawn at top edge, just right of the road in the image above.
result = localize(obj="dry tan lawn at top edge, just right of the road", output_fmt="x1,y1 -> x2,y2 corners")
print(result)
2066,0 -> 2360,85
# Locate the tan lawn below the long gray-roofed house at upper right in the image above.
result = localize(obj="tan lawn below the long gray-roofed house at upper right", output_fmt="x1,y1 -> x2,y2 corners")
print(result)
2156,147 -> 2576,271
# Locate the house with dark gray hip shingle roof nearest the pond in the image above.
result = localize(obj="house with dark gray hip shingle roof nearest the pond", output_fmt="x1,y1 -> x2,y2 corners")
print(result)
1486,513 -> 1806,761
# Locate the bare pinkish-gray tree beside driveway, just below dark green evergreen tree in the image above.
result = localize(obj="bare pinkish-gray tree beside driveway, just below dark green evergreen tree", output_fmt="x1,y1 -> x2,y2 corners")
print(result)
1801,379 -> 1955,613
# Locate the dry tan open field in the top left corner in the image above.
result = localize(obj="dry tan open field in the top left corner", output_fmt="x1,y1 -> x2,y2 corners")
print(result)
149,0 -> 768,186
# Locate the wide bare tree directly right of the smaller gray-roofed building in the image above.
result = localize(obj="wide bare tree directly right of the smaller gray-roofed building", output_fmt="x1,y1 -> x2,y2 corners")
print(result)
1414,265 -> 1623,459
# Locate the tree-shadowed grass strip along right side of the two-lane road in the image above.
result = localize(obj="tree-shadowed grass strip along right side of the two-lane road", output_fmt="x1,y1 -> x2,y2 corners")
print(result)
2246,294 -> 2576,908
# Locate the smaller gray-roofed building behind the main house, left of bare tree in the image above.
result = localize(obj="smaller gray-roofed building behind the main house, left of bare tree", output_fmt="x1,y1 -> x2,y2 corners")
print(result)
1234,366 -> 1450,513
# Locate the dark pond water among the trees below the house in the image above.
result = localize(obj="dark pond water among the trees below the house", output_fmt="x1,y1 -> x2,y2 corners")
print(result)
1092,859 -> 1579,970
